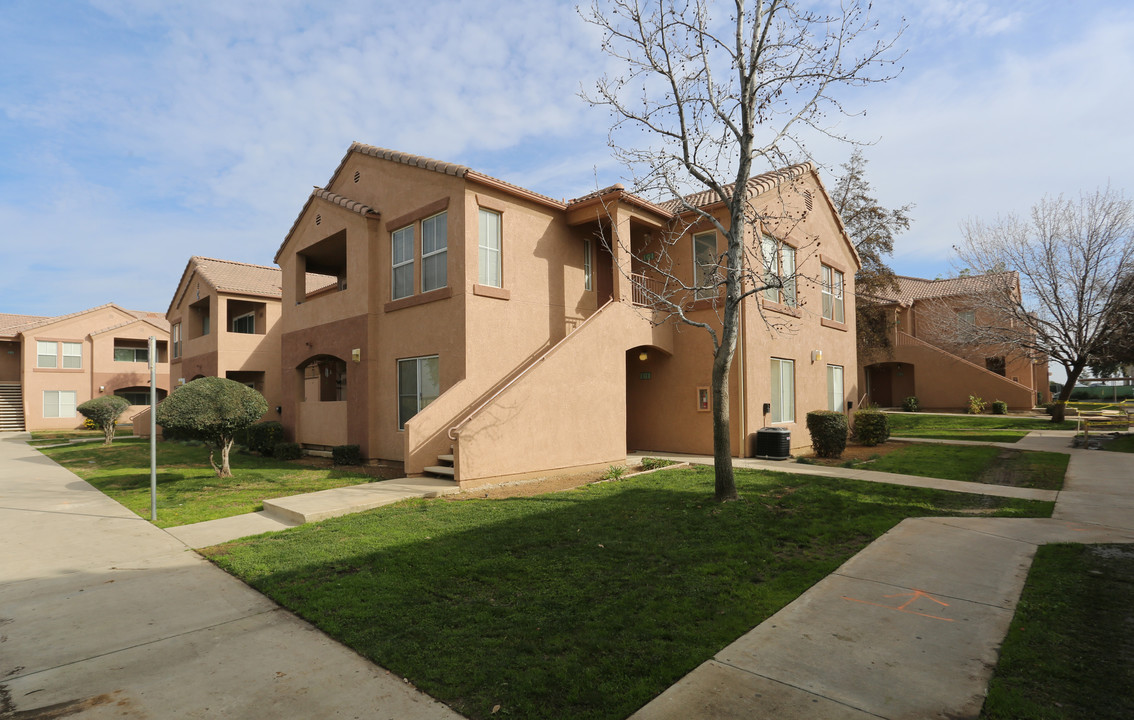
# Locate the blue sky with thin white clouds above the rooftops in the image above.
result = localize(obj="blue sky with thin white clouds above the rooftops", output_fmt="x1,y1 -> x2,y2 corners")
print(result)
0,0 -> 1134,315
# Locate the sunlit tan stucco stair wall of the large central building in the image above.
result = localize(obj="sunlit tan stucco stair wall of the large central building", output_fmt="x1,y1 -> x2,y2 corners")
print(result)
454,303 -> 674,486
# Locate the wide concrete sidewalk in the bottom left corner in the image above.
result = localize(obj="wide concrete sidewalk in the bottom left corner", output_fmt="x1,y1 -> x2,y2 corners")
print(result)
0,433 -> 460,720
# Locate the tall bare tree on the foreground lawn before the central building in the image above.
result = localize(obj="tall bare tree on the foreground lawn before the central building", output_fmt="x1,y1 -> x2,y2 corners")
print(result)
584,0 -> 900,501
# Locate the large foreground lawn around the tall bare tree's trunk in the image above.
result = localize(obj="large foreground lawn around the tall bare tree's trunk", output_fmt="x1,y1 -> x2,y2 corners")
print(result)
204,468 -> 1052,720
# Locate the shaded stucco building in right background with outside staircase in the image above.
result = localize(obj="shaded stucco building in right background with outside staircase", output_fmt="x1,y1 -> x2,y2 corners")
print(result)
858,272 -> 1051,412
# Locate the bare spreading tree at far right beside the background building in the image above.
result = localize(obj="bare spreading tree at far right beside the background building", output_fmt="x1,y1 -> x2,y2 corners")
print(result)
955,187 -> 1134,421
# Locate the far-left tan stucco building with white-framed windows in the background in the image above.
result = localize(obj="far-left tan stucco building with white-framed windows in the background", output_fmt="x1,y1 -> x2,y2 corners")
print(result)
0,303 -> 169,431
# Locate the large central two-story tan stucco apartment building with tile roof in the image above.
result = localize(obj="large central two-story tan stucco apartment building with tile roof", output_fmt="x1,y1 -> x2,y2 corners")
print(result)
272,143 -> 858,486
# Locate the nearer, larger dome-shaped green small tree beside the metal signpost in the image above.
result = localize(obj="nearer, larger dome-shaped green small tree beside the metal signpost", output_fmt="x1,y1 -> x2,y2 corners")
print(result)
156,378 -> 268,477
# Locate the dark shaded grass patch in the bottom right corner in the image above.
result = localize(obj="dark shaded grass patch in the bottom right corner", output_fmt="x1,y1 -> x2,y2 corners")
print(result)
981,544 -> 1134,720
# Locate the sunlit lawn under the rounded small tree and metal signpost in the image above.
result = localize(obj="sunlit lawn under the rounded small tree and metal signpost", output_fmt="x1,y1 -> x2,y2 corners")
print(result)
40,440 -> 374,527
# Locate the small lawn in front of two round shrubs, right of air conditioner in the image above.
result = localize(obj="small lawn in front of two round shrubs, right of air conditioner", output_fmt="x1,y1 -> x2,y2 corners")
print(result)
853,443 -> 1070,490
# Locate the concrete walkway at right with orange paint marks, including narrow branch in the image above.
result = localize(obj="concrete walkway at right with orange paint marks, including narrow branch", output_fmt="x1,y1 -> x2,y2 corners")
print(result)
633,431 -> 1134,720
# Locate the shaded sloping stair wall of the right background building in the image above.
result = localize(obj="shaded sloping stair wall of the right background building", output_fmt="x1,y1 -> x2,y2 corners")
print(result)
891,332 -> 1035,409
